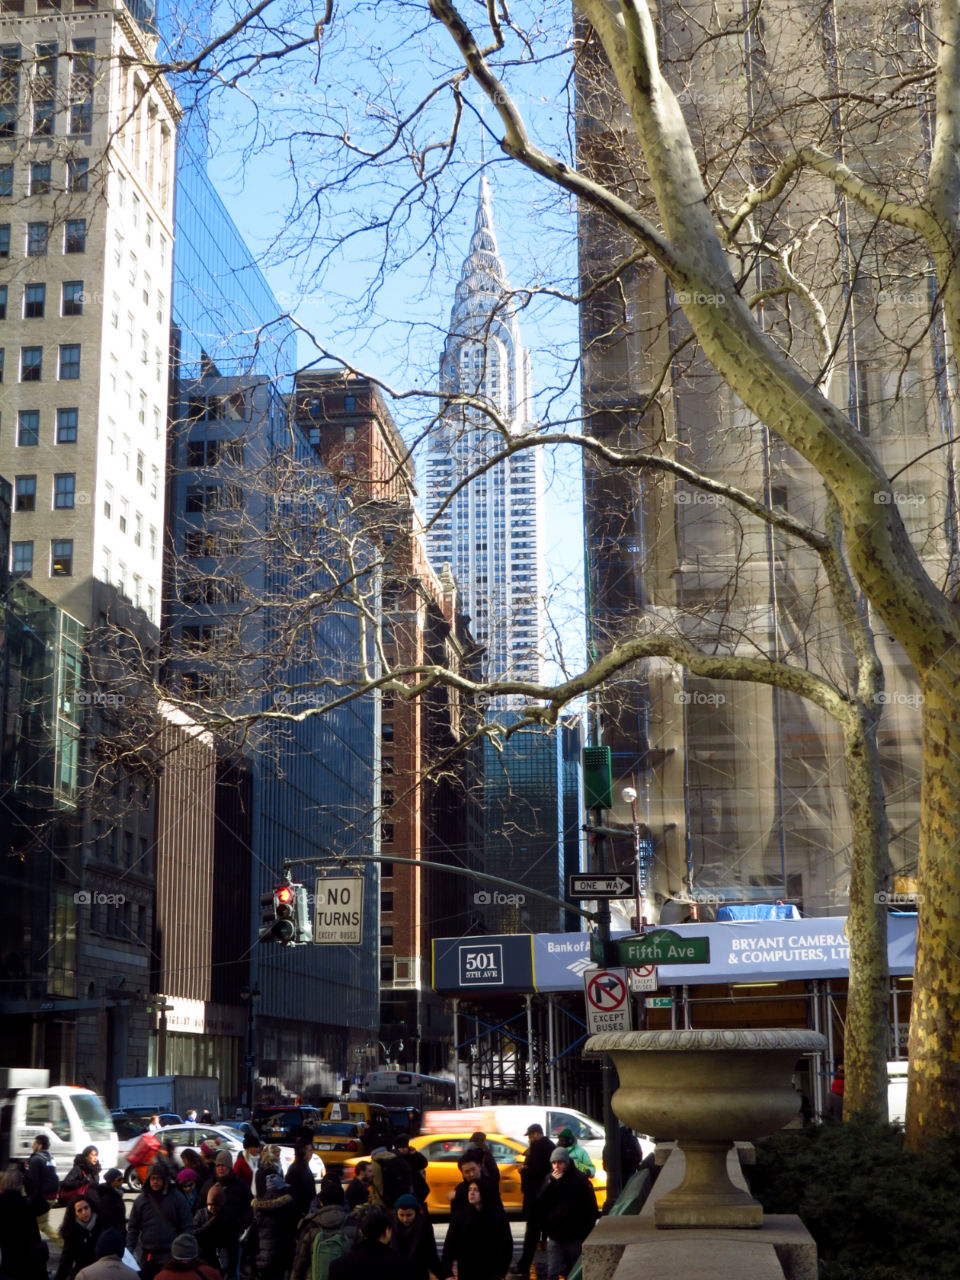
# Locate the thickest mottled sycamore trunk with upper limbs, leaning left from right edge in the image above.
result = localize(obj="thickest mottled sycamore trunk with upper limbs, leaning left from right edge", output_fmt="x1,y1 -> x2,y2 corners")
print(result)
431,0 -> 960,1148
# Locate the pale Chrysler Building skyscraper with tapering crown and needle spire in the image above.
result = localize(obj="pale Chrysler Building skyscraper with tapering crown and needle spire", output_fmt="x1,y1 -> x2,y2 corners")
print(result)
425,177 -> 543,680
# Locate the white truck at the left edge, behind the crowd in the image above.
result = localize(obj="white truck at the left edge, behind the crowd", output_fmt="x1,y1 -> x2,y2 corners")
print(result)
0,1066 -> 116,1178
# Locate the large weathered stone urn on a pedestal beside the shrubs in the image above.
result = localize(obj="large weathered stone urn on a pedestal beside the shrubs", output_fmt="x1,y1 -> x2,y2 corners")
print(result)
584,1028 -> 827,1228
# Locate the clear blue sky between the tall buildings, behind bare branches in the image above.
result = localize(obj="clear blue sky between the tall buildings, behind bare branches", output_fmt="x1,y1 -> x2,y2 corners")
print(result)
195,4 -> 584,680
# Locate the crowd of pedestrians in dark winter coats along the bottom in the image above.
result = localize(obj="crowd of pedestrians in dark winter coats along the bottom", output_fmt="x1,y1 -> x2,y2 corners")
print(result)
0,1125 -> 624,1280
